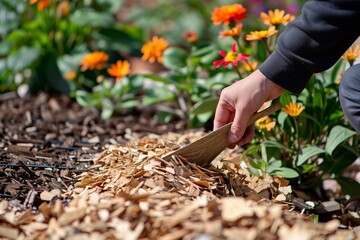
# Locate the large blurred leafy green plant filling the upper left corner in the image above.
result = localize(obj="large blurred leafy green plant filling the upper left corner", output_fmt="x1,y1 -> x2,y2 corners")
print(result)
0,0 -> 142,94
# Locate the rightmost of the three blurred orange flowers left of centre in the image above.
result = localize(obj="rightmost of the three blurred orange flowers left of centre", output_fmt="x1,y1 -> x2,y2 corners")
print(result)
141,36 -> 169,63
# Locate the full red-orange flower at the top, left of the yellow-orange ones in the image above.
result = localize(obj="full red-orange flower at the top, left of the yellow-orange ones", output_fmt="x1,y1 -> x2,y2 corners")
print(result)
211,4 -> 246,25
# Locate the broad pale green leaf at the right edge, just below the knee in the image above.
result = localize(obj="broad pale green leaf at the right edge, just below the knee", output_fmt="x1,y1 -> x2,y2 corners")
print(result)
325,125 -> 356,155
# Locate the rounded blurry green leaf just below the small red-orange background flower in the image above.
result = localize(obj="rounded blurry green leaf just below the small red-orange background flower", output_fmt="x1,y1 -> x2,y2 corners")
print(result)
163,47 -> 187,70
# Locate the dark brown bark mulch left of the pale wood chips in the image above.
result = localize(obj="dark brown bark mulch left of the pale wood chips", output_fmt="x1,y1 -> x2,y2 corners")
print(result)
0,93 -> 185,208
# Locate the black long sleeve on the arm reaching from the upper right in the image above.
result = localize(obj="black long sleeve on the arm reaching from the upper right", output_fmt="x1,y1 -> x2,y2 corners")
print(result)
260,0 -> 360,93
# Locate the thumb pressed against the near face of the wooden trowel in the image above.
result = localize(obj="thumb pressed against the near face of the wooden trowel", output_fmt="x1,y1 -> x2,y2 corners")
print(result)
228,111 -> 250,143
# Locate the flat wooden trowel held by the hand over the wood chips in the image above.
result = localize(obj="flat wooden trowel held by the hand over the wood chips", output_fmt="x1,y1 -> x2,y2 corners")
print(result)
162,102 -> 281,165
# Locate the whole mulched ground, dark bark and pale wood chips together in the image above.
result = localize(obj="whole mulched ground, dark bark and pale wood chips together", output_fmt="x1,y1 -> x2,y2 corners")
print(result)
0,94 -> 358,239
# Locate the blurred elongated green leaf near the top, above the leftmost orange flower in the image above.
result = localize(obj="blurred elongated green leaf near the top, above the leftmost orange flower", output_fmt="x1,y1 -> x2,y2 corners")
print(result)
70,9 -> 114,27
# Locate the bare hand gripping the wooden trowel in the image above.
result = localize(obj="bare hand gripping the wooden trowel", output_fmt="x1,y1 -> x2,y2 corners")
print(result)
214,70 -> 284,148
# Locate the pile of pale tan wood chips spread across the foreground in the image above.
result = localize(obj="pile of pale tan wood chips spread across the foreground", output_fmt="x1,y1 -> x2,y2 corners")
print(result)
0,135 -> 356,240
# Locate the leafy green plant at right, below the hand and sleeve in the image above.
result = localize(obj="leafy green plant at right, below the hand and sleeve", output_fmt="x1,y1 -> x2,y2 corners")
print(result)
246,55 -> 360,195
